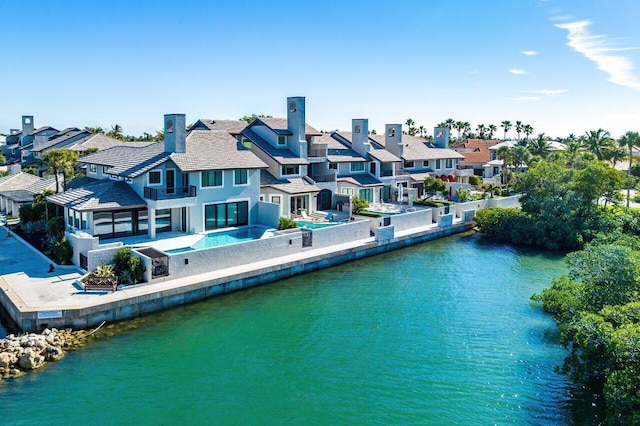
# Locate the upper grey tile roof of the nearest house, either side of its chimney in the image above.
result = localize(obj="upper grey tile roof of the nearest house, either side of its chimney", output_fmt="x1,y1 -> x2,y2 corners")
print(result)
80,130 -> 267,178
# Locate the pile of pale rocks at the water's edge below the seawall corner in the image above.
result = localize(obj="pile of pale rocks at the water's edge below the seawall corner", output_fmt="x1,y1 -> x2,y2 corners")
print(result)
0,328 -> 91,380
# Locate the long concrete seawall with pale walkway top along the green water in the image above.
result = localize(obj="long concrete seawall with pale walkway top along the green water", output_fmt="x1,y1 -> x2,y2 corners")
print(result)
0,224 -> 473,331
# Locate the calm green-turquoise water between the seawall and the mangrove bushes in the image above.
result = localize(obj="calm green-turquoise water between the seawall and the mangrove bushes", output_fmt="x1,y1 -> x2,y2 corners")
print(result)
0,236 -> 574,425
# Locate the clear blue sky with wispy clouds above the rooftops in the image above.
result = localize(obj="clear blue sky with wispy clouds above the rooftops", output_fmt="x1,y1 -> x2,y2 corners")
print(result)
0,0 -> 640,137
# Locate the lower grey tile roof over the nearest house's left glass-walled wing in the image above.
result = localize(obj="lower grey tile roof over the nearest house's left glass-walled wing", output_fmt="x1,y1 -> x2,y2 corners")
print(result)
47,179 -> 147,211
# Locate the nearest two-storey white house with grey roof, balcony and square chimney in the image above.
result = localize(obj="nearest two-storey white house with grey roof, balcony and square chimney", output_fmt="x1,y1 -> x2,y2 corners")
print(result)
49,114 -> 266,243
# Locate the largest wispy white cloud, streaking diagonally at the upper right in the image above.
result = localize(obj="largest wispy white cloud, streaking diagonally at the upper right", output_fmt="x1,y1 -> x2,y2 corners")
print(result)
555,21 -> 640,91
